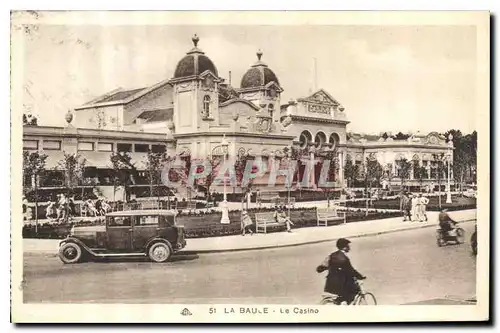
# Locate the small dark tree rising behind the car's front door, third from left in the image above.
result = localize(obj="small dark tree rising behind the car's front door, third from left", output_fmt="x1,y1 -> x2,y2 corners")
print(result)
110,152 -> 137,202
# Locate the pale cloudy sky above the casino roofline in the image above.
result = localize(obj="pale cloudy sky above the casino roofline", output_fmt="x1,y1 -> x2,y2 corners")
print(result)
19,24 -> 477,133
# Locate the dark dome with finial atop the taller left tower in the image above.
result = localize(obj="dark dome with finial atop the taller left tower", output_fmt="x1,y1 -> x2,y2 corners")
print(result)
174,35 -> 218,79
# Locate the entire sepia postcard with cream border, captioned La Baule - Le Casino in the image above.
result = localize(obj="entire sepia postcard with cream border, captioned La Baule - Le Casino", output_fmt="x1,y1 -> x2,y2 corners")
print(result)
11,11 -> 490,323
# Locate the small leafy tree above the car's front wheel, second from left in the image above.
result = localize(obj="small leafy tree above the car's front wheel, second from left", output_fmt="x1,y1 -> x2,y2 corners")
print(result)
56,153 -> 87,222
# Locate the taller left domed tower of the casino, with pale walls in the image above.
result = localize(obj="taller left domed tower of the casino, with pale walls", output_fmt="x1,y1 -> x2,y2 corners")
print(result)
170,35 -> 222,134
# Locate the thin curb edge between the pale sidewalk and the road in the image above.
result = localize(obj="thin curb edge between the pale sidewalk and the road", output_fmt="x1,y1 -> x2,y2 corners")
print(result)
24,219 -> 477,258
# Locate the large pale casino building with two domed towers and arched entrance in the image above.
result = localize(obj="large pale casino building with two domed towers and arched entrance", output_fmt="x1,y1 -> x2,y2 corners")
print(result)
23,35 -> 453,198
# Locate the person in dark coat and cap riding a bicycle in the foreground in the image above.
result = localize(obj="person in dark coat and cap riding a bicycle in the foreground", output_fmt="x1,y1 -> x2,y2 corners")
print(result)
316,238 -> 366,305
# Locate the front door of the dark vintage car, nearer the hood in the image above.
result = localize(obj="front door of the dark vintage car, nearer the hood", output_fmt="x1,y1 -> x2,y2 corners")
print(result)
107,216 -> 133,252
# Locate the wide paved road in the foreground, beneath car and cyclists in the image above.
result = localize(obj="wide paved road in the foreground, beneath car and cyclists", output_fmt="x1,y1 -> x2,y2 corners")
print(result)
24,223 -> 476,304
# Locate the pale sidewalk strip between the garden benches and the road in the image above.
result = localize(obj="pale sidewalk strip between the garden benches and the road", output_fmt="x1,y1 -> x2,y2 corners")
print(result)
23,209 -> 476,255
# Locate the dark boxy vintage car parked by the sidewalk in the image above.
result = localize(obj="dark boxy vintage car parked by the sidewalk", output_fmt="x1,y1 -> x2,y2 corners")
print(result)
59,210 -> 186,264
